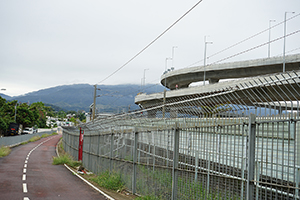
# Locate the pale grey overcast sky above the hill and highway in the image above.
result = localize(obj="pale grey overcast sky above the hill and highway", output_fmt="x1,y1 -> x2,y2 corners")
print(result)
0,0 -> 300,96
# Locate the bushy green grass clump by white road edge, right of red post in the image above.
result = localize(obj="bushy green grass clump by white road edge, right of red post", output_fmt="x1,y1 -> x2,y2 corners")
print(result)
90,171 -> 125,191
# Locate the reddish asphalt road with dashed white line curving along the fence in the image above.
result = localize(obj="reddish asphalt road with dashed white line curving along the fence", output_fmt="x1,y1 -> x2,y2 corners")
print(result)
0,135 -> 106,200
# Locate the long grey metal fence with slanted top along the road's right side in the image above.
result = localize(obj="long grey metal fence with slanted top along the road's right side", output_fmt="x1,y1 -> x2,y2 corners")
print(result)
63,71 -> 300,200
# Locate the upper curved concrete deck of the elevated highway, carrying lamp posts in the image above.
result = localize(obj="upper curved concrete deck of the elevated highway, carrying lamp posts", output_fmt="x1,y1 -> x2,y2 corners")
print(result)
161,54 -> 300,90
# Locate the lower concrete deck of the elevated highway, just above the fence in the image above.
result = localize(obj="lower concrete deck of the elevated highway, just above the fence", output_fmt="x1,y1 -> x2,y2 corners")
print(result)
135,70 -> 300,108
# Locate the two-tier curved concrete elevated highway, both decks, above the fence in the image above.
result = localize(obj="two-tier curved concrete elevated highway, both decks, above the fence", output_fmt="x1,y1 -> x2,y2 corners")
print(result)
135,54 -> 300,115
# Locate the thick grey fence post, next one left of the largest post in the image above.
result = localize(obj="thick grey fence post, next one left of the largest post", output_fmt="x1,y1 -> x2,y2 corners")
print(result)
172,123 -> 179,200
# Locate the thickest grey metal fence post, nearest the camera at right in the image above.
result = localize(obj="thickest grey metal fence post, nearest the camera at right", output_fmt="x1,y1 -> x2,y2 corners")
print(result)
246,114 -> 256,200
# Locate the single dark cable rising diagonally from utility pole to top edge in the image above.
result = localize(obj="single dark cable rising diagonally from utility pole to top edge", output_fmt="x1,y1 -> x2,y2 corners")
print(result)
97,0 -> 202,84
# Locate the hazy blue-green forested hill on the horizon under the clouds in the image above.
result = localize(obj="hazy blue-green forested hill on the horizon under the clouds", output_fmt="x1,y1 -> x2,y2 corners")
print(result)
0,84 -> 164,113
